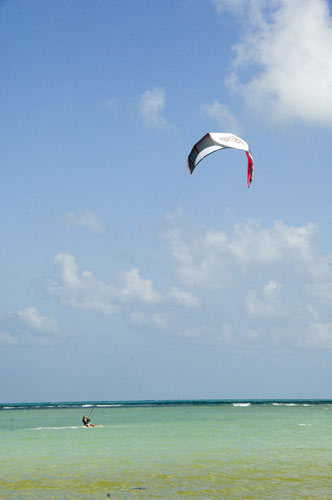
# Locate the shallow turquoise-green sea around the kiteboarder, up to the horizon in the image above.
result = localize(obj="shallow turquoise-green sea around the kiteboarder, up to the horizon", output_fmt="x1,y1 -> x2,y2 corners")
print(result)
0,401 -> 332,500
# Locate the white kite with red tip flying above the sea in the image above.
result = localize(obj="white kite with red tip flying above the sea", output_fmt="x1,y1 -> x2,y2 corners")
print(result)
188,132 -> 254,187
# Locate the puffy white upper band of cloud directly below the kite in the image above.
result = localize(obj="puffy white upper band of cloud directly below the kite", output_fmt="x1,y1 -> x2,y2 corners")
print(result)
166,221 -> 320,289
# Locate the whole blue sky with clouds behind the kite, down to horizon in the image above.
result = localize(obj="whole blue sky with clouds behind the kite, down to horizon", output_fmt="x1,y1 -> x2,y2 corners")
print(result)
0,0 -> 332,402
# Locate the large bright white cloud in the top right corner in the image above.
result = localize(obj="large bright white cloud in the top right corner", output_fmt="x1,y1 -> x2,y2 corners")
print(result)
220,0 -> 332,124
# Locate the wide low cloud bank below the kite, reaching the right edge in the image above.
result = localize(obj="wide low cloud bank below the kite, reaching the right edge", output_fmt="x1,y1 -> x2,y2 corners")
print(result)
46,219 -> 332,350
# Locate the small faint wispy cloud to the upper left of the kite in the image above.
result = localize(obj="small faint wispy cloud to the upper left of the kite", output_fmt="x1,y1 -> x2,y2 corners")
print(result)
137,88 -> 167,128
